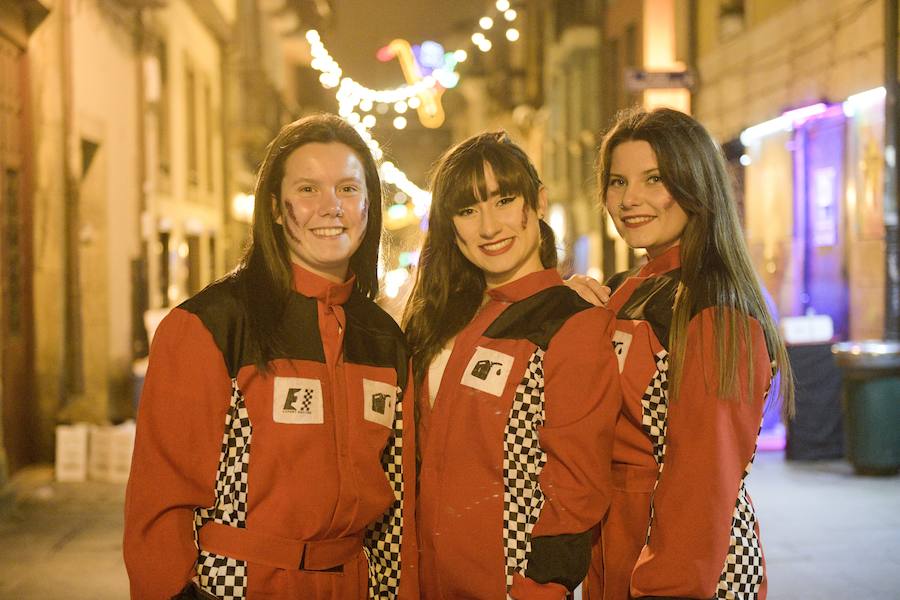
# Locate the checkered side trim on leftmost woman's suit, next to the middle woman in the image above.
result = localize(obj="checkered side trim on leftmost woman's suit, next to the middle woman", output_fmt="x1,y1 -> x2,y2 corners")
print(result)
364,388 -> 404,600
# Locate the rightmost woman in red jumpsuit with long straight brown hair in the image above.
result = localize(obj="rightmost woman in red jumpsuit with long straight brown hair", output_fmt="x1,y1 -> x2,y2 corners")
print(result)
582,109 -> 793,600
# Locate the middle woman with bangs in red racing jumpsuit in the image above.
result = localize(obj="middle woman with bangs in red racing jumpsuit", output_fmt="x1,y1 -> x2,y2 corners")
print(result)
403,132 -> 621,599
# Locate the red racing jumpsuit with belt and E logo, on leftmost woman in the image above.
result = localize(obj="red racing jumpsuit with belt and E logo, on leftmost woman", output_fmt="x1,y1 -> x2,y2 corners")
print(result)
124,265 -> 418,600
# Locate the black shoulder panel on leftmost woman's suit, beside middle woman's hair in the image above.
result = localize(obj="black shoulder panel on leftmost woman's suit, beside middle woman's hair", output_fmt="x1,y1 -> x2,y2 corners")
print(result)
344,290 -> 409,387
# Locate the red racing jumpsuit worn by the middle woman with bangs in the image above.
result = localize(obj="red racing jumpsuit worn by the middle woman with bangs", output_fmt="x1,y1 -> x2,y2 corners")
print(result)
417,269 -> 621,600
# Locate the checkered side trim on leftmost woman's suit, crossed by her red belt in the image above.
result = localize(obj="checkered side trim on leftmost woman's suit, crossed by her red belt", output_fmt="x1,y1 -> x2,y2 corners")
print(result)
194,379 -> 253,600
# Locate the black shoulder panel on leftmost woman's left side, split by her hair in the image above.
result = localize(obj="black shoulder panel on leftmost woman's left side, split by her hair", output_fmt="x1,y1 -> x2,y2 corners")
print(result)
179,279 -> 325,377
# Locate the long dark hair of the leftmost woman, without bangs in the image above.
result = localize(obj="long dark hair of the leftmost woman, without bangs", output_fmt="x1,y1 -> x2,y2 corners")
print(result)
234,114 -> 382,370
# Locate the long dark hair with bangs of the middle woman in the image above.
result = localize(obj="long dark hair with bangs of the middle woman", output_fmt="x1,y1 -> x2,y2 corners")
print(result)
403,131 -> 557,383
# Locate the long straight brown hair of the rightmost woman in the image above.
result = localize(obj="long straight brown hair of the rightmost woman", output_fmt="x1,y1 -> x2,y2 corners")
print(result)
598,108 -> 794,416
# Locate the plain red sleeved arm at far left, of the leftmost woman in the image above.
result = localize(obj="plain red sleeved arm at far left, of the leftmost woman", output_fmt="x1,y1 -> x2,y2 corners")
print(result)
123,308 -> 231,599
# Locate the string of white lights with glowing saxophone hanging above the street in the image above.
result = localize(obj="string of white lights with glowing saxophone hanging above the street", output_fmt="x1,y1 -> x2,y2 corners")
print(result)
306,0 -> 520,218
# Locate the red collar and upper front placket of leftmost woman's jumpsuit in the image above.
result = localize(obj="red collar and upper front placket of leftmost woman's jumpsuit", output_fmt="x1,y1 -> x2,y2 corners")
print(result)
291,263 -> 356,369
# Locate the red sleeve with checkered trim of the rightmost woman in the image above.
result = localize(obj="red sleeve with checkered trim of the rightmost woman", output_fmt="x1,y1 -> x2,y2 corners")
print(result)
631,309 -> 771,600
